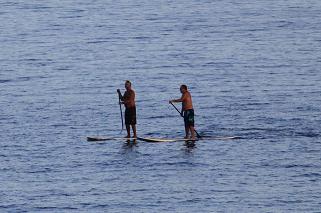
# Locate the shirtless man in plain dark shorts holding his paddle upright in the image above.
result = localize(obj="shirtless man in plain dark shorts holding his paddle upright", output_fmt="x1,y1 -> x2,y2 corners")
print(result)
117,81 -> 137,138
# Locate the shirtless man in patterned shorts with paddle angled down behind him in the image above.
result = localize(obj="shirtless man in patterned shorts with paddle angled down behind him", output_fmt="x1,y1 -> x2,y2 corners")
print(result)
169,85 -> 195,139
